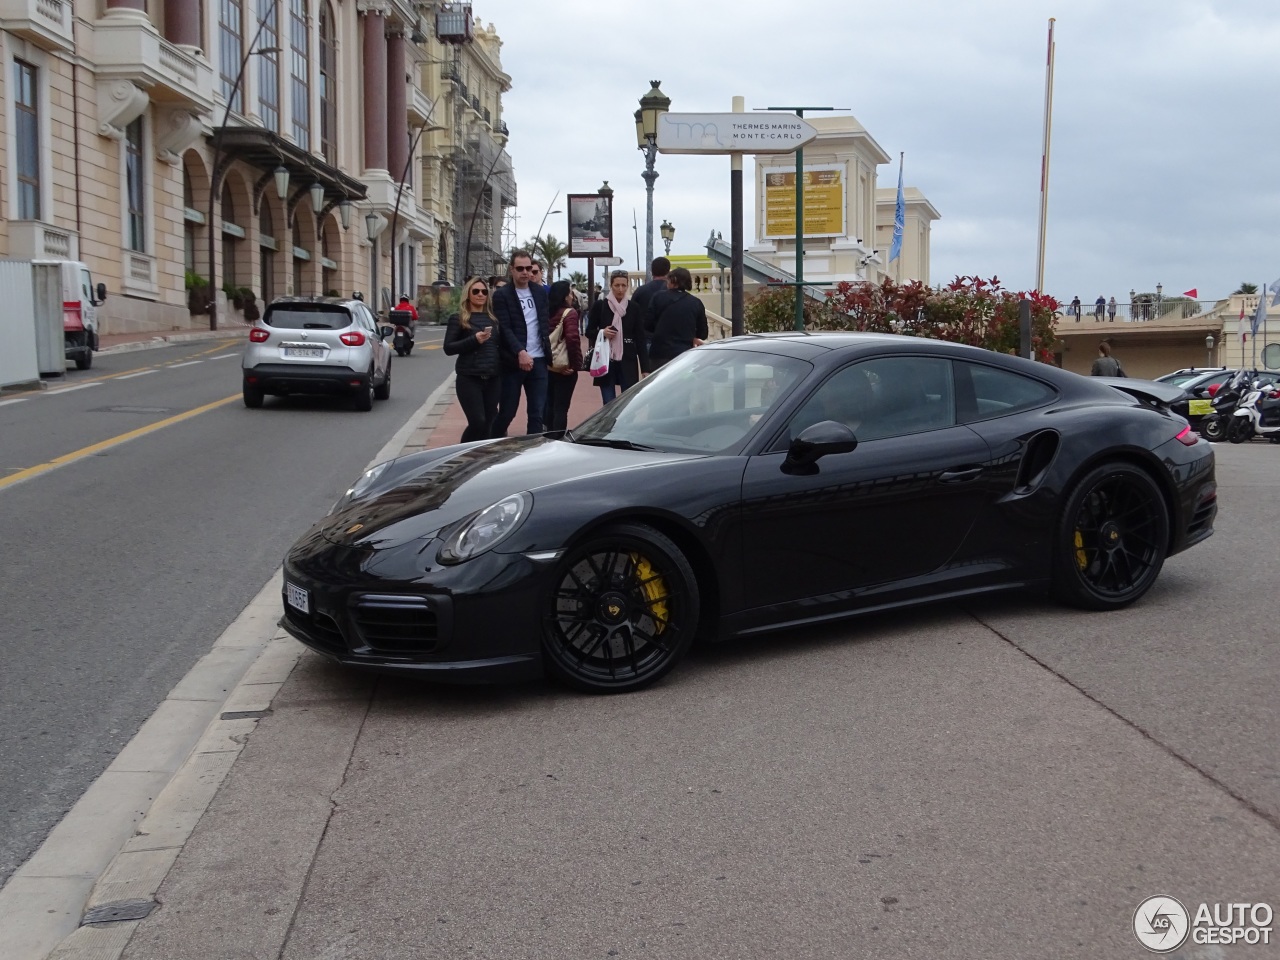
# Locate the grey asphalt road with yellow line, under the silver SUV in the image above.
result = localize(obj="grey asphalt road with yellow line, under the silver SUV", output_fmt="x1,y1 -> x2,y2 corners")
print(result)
0,328 -> 452,883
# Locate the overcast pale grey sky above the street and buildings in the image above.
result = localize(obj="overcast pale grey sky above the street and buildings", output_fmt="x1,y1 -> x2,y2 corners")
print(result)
472,0 -> 1280,302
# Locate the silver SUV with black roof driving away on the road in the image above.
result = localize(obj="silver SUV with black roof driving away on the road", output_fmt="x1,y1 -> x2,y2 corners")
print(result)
241,297 -> 394,410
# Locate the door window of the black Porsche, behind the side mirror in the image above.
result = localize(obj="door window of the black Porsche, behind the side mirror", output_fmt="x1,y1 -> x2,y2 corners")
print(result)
788,357 -> 955,440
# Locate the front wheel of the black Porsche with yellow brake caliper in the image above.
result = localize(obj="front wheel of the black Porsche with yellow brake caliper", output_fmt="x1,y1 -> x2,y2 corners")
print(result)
543,524 -> 699,692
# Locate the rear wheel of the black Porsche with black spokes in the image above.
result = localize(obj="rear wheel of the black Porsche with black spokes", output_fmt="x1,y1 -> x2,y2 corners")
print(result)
1053,463 -> 1169,611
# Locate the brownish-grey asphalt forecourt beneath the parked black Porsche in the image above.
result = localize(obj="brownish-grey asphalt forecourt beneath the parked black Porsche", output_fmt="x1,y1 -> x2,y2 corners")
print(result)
124,443 -> 1280,960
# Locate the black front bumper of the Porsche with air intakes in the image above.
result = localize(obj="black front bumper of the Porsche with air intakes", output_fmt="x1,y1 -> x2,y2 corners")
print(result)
280,532 -> 547,684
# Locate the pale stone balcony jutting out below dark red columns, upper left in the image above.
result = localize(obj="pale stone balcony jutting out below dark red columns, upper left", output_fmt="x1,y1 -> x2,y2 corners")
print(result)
93,13 -> 214,114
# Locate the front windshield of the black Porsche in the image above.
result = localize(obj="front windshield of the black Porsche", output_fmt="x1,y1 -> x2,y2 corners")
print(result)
566,348 -> 813,453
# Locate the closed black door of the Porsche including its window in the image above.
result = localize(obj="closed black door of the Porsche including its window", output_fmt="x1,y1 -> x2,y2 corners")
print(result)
742,356 -> 989,622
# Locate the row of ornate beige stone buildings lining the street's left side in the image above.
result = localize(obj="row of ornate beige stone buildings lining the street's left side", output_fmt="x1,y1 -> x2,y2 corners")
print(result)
0,0 -> 515,333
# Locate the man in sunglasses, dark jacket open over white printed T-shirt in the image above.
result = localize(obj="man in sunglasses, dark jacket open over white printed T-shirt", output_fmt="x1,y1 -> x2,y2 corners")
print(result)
493,250 -> 552,436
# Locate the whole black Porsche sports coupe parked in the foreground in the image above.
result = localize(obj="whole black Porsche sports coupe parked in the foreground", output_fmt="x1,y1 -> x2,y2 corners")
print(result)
282,334 -> 1217,691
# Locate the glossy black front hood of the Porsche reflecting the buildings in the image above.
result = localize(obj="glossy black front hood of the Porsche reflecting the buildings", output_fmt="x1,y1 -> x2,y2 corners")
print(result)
320,436 -> 703,549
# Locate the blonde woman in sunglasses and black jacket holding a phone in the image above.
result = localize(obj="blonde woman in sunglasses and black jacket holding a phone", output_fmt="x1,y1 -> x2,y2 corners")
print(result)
444,276 -> 502,443
